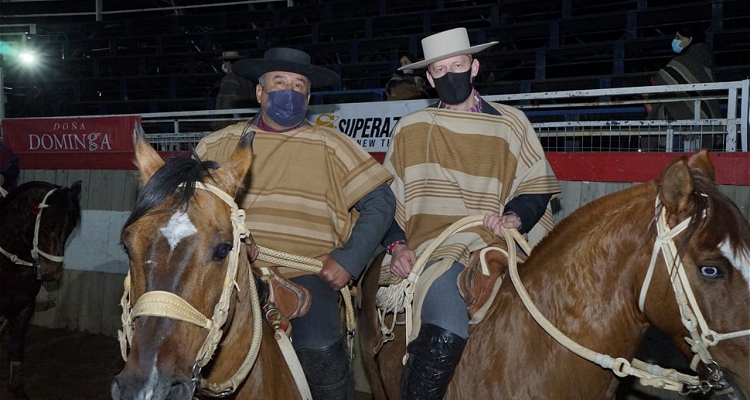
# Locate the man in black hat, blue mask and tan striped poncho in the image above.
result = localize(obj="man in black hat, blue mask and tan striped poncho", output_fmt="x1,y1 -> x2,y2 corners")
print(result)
195,48 -> 395,400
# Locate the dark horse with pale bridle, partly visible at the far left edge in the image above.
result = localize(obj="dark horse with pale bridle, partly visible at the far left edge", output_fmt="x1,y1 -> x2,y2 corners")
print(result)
0,181 -> 81,399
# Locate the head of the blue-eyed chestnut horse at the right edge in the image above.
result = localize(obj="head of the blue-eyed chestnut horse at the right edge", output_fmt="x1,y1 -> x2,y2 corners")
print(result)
639,151 -> 750,398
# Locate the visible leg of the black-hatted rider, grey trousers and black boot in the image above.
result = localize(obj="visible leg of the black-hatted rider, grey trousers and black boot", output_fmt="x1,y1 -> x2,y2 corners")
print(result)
292,275 -> 354,400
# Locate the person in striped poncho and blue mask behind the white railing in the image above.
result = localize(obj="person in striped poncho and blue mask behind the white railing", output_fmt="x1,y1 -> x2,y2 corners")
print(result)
641,25 -> 723,151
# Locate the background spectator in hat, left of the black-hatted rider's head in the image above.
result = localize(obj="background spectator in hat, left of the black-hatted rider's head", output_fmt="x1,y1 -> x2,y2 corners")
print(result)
211,51 -> 255,130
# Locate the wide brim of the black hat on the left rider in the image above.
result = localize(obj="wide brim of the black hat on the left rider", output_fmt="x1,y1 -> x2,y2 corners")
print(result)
232,58 -> 341,88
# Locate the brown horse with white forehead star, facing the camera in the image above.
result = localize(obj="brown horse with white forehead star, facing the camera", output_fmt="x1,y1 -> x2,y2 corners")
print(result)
112,131 -> 301,400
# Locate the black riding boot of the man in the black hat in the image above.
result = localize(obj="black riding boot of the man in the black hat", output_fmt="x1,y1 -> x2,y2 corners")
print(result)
297,336 -> 354,400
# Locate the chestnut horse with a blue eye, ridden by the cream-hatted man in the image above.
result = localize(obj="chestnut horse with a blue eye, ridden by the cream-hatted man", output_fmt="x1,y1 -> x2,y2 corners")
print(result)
360,151 -> 750,400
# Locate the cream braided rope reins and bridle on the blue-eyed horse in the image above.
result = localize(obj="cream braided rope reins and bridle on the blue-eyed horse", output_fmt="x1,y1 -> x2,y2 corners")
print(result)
375,202 -> 750,394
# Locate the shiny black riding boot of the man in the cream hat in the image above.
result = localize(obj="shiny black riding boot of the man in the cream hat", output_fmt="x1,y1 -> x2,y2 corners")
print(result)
399,324 -> 466,400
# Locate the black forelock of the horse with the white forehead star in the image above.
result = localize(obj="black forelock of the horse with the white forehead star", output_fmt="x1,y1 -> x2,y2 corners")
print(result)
124,155 -> 219,227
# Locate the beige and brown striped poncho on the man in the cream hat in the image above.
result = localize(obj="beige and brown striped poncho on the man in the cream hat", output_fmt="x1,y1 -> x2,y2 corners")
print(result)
383,102 -> 561,265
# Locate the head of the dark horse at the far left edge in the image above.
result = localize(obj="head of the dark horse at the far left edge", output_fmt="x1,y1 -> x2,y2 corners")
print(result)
0,181 -> 81,281
